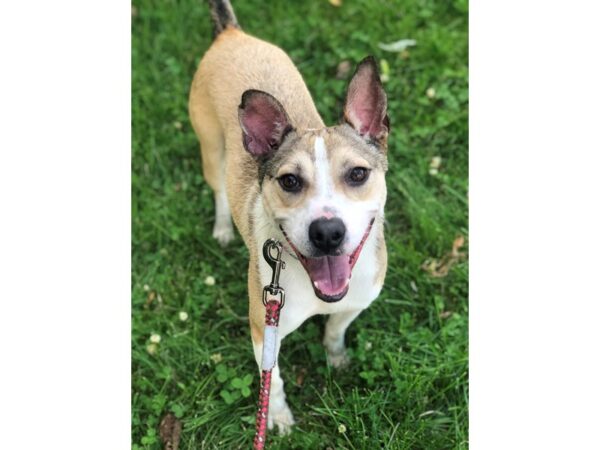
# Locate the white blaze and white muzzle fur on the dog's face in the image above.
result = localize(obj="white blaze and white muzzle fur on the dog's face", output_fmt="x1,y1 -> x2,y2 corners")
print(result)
284,136 -> 380,256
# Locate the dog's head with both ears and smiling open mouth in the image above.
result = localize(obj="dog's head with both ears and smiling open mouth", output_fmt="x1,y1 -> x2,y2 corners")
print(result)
239,57 -> 389,302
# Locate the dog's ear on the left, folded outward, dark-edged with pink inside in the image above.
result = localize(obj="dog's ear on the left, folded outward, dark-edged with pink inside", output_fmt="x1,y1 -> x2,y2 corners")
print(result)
238,89 -> 293,158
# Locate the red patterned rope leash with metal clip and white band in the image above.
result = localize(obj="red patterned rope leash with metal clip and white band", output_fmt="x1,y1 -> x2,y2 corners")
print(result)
254,239 -> 285,450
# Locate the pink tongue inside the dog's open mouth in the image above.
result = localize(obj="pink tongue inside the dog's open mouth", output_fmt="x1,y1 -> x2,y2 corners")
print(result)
306,255 -> 351,295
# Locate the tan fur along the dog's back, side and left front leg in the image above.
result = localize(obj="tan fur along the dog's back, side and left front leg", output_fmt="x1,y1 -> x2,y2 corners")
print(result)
189,28 -> 324,340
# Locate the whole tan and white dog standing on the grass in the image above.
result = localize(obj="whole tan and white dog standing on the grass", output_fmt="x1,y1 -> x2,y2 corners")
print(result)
189,0 -> 389,432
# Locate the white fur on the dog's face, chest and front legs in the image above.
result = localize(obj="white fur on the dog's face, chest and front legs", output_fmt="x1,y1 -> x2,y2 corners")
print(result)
253,137 -> 383,433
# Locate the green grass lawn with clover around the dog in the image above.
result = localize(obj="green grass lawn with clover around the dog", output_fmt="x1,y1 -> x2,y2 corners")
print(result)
132,0 -> 468,449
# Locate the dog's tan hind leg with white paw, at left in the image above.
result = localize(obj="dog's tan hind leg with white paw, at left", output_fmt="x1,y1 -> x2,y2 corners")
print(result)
189,84 -> 233,246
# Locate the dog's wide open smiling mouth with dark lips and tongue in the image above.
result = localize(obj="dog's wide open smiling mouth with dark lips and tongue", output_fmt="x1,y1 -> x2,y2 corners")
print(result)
279,219 -> 375,303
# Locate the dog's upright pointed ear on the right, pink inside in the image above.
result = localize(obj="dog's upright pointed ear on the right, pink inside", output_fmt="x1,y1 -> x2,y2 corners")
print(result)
344,56 -> 390,148
